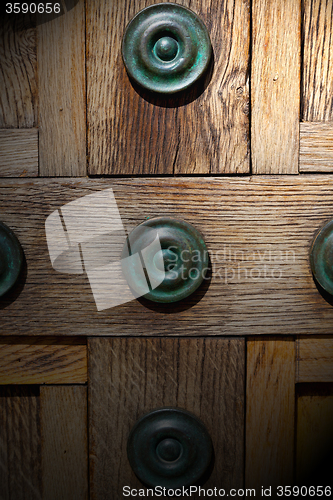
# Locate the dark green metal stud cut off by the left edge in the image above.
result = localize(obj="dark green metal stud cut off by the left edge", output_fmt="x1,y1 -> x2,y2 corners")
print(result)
0,222 -> 23,297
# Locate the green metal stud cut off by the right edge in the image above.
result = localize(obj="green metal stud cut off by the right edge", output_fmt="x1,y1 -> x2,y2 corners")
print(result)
310,220 -> 333,295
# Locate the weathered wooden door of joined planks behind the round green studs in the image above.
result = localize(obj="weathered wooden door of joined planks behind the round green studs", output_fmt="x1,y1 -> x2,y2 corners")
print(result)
0,0 -> 333,500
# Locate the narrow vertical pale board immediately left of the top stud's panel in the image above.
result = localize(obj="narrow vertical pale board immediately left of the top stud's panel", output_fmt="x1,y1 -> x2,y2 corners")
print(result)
38,0 -> 86,177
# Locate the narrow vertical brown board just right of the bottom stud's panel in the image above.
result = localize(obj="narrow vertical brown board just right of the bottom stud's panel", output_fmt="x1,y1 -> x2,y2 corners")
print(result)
245,338 -> 295,488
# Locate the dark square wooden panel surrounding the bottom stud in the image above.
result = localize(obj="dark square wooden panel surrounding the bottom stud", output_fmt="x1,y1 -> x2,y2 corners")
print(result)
88,338 -> 245,500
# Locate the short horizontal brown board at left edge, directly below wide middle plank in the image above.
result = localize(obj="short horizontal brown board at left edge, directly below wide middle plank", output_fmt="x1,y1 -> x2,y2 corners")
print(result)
0,337 -> 87,385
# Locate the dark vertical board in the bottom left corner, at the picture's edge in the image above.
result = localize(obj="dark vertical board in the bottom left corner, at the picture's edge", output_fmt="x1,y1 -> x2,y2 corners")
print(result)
0,387 -> 42,500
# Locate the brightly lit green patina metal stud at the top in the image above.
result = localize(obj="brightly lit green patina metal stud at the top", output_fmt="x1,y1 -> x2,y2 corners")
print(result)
122,3 -> 212,94
